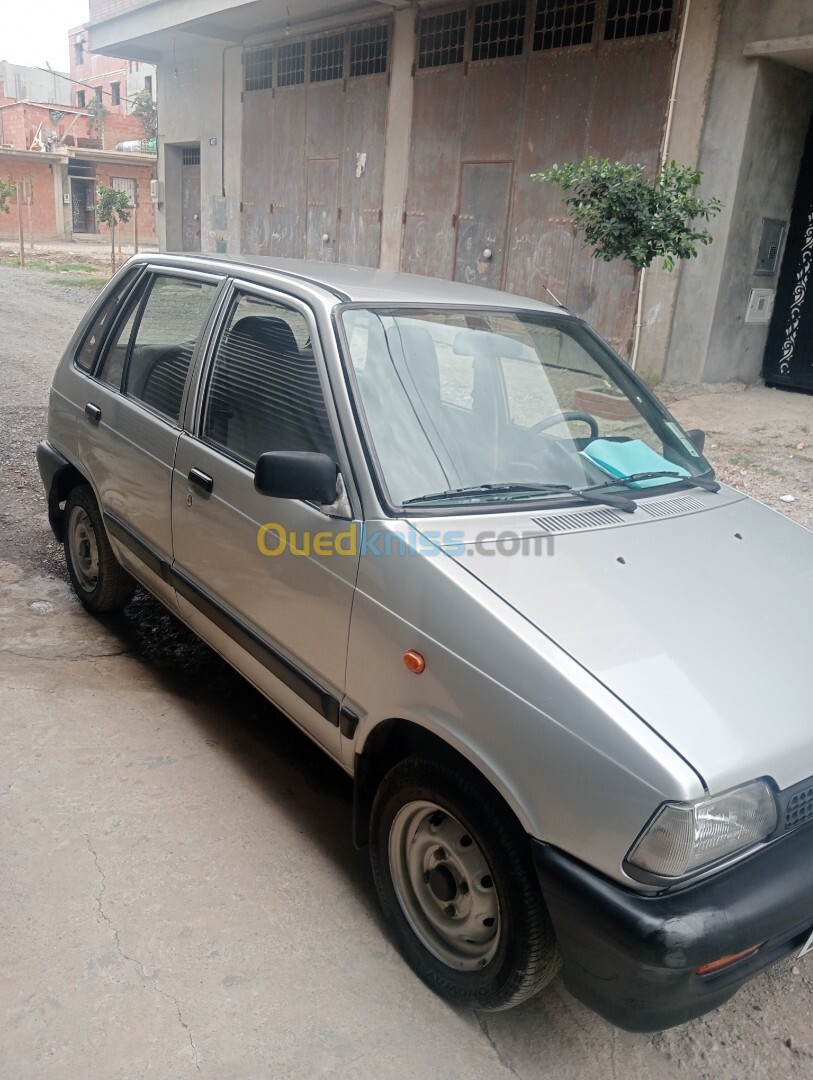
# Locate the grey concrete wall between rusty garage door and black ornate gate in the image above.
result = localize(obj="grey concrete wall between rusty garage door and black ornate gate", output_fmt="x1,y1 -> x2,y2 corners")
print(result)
664,0 -> 813,382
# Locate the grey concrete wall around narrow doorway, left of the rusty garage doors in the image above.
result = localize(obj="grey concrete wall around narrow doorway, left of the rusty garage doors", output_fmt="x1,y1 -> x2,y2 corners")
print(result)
158,39 -> 242,252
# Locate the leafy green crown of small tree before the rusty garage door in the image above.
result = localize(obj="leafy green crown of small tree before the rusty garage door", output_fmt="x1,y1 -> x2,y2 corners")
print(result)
531,158 -> 722,271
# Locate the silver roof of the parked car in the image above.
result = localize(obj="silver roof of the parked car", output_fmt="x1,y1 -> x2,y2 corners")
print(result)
136,252 -> 565,312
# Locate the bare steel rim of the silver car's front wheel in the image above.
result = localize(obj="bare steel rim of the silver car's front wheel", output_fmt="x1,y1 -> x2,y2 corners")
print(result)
389,800 -> 501,971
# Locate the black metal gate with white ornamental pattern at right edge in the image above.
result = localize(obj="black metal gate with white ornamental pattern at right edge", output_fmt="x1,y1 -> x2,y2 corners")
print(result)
763,125 -> 813,391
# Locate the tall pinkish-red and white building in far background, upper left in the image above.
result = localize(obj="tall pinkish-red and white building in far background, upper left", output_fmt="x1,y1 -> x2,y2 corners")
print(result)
68,25 -> 155,124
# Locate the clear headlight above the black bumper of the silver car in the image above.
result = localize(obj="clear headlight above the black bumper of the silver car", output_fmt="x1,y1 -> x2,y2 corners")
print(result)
627,780 -> 776,878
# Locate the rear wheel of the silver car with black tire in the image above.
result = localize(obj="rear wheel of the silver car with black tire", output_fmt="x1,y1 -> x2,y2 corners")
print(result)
64,484 -> 136,615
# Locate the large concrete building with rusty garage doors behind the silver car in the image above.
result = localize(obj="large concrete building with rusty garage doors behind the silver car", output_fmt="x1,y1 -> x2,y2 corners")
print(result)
89,0 -> 813,389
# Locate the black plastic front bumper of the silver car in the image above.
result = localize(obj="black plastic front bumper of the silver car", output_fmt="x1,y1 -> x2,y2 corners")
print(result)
533,824 -> 813,1031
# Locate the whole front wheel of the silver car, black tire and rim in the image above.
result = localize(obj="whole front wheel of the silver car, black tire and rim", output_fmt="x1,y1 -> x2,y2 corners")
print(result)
370,756 -> 561,1010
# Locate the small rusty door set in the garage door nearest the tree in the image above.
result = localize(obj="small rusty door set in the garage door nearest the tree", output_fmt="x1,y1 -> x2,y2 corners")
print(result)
455,161 -> 514,288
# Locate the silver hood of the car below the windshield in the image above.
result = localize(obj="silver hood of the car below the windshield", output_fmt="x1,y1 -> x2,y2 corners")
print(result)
421,489 -> 813,791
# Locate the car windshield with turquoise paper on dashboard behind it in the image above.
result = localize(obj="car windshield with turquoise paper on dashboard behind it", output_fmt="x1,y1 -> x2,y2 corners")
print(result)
341,307 -> 712,508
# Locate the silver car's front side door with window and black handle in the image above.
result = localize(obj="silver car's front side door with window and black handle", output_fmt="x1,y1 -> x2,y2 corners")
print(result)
173,286 -> 361,756
